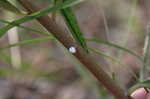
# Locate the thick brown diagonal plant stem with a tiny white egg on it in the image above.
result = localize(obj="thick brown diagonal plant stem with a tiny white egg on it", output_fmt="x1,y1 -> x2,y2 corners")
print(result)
19,0 -> 131,99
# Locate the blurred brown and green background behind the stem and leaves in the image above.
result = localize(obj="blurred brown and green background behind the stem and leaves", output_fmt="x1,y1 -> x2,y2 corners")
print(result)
0,0 -> 150,99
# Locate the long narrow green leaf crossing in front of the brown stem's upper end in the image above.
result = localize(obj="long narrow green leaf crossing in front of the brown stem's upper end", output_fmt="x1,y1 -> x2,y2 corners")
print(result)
0,0 -> 84,37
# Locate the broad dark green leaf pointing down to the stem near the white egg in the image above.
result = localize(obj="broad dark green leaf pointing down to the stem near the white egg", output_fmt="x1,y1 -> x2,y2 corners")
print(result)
55,0 -> 88,52
